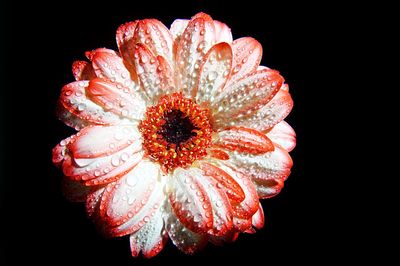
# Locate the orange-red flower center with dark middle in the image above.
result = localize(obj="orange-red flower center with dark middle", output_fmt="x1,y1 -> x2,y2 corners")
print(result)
139,93 -> 212,172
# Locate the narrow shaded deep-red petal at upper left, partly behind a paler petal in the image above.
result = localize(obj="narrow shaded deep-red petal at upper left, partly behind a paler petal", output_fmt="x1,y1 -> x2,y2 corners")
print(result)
116,20 -> 138,82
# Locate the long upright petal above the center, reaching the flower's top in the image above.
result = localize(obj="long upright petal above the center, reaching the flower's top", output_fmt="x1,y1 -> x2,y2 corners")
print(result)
175,13 -> 215,97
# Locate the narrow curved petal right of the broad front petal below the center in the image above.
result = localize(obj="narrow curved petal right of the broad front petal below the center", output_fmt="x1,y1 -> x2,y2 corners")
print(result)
194,169 -> 233,236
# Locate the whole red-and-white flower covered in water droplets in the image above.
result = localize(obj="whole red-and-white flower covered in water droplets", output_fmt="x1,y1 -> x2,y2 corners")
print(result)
53,13 -> 296,257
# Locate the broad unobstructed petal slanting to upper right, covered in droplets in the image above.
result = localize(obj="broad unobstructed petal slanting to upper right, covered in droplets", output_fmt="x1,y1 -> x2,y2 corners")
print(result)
212,69 -> 283,126
